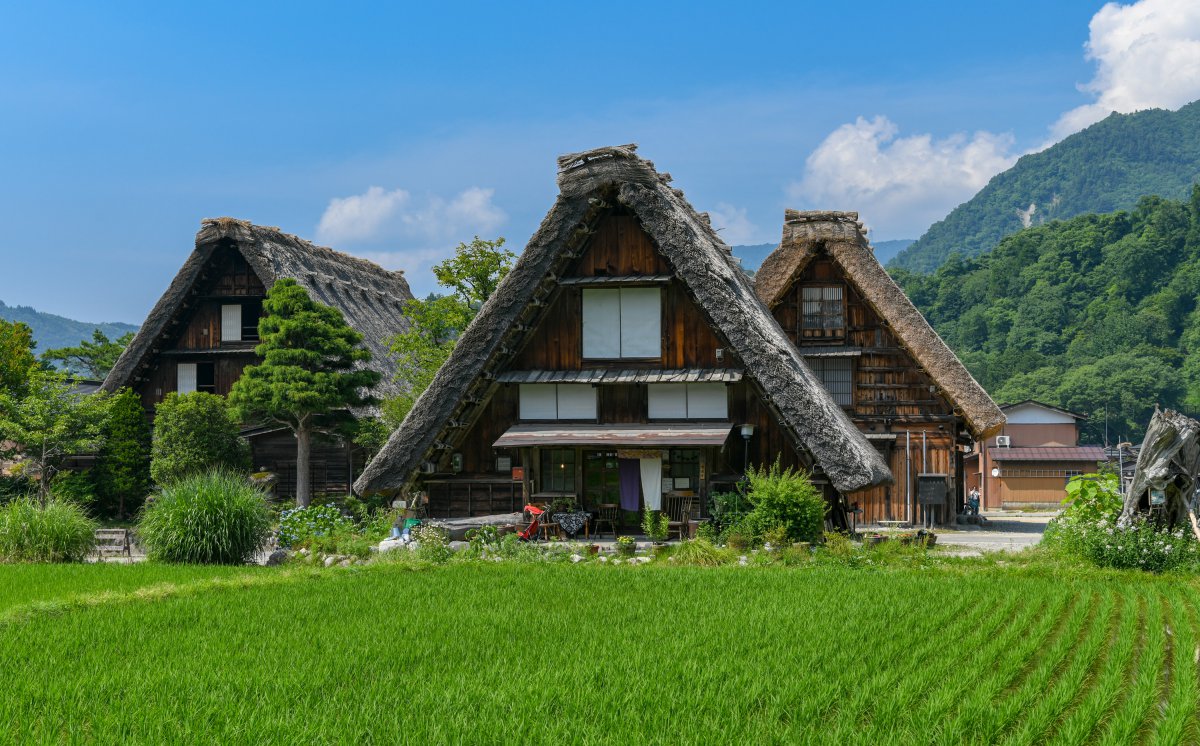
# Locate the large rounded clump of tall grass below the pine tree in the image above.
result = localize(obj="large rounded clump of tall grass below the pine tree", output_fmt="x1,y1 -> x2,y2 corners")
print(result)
138,470 -> 271,565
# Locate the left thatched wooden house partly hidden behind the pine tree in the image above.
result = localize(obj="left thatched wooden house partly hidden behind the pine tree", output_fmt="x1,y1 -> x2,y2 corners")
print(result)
102,218 -> 413,497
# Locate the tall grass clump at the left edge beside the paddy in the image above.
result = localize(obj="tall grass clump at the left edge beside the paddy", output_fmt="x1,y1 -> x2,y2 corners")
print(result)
0,498 -> 96,562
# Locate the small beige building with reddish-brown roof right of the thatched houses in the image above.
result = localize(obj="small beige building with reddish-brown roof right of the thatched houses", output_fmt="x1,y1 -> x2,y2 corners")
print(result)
966,399 -> 1105,510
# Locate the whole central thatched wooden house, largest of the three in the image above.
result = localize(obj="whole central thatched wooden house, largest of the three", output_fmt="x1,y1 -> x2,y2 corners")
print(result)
356,146 -> 890,517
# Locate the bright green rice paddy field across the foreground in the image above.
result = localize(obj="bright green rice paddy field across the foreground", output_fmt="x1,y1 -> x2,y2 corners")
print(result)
0,564 -> 1200,744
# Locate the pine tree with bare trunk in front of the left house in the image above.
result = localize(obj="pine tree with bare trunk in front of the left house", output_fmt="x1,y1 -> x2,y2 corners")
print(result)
229,278 -> 380,507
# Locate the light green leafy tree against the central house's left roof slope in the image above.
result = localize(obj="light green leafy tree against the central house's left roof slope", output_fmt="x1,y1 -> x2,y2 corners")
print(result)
383,236 -> 516,427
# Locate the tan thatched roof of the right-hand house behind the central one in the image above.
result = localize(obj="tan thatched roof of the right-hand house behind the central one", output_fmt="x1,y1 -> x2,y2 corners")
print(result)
755,210 -> 1004,438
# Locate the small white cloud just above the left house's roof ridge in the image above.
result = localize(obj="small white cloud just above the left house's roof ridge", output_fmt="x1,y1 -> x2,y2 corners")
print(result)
317,186 -> 508,245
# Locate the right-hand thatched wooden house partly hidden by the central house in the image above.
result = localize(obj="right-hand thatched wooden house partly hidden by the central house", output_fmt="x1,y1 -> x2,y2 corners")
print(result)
755,210 -> 1004,523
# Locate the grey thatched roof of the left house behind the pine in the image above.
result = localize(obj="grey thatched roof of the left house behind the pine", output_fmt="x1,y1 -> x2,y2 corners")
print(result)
103,217 -> 413,396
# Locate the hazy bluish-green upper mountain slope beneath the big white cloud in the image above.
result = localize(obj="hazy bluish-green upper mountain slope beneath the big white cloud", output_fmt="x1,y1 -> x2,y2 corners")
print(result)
892,102 -> 1200,272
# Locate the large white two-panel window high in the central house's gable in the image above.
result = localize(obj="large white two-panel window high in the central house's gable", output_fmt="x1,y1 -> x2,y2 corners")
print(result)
583,288 -> 662,360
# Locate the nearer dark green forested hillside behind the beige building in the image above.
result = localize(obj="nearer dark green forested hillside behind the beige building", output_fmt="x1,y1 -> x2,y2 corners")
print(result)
893,188 -> 1200,443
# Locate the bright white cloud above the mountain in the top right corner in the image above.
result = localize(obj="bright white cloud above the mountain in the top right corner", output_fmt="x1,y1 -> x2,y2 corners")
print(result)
1051,0 -> 1200,140
